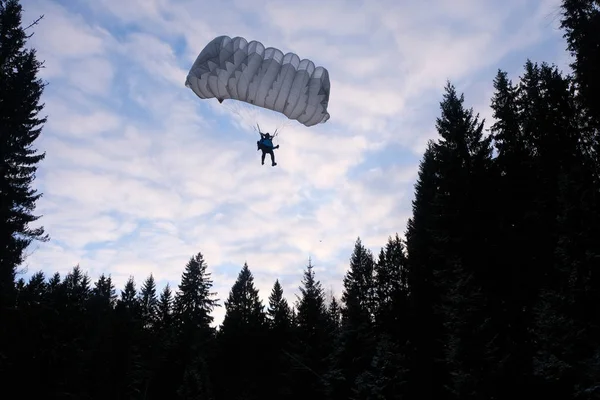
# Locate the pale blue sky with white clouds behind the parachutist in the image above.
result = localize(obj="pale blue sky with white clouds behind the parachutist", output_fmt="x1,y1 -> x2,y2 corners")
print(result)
21,0 -> 569,324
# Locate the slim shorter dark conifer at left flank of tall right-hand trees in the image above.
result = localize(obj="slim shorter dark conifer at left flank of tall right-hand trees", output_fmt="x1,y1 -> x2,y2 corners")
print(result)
406,141 -> 448,399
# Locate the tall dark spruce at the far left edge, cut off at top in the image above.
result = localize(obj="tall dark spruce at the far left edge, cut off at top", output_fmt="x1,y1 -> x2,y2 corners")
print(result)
0,0 -> 49,306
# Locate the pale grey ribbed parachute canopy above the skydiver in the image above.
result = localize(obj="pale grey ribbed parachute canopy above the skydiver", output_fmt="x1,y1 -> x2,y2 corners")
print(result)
185,36 -> 330,127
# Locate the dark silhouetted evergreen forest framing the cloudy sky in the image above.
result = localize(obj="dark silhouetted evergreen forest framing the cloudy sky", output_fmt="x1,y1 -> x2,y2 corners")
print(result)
0,0 -> 600,400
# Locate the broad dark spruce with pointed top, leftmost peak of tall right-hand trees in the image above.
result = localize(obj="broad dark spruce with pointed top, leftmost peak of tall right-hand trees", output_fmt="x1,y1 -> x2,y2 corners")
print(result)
406,83 -> 494,398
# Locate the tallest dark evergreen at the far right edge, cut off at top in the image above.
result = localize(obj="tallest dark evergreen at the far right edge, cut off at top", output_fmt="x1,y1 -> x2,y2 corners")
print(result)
530,0 -> 600,399
